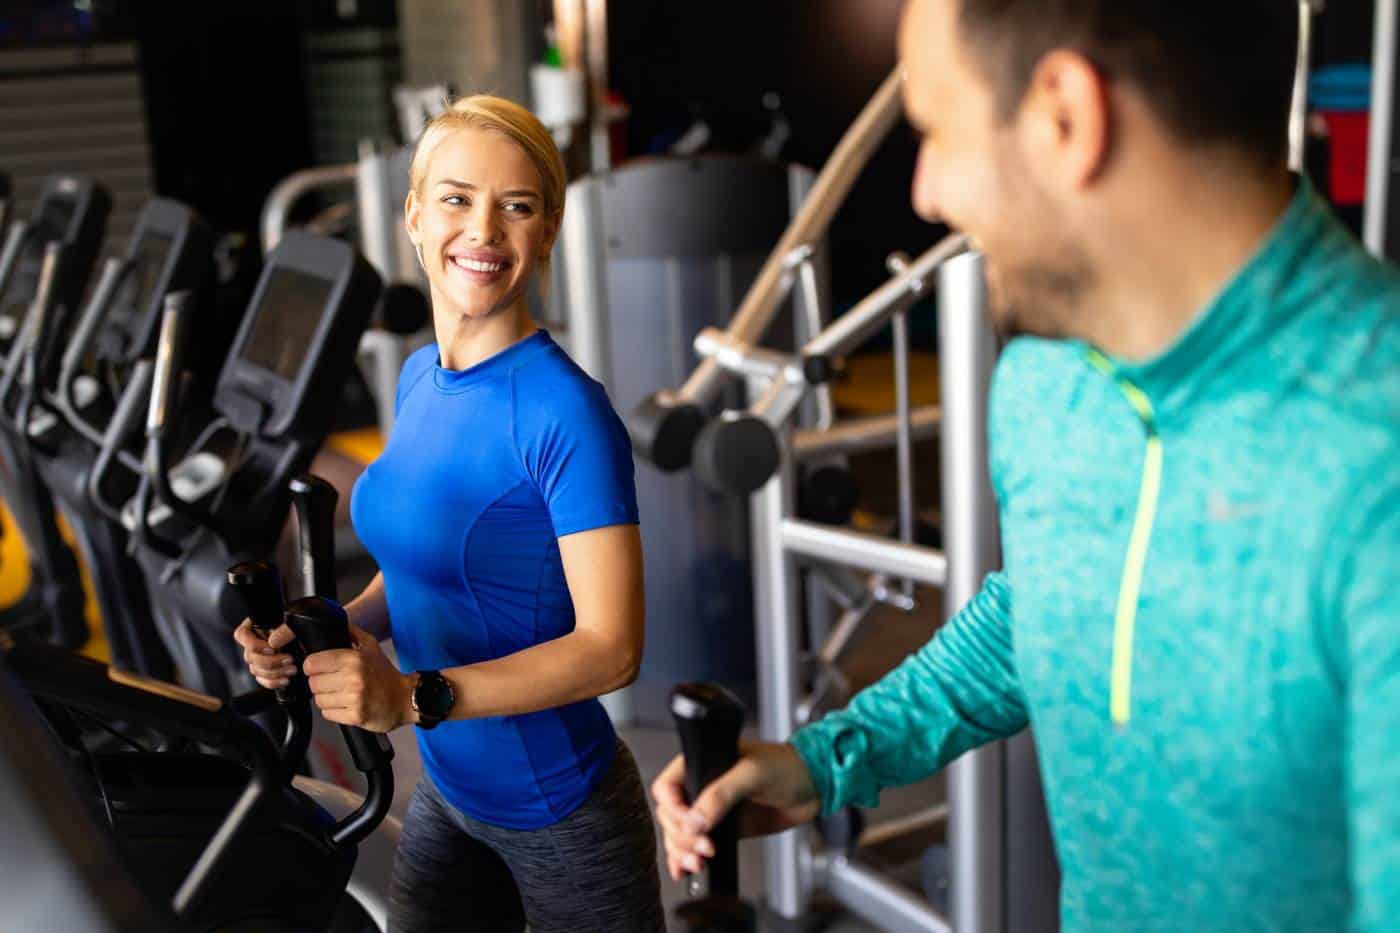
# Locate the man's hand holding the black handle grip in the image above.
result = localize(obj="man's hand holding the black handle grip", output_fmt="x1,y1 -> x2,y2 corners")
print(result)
651,742 -> 822,881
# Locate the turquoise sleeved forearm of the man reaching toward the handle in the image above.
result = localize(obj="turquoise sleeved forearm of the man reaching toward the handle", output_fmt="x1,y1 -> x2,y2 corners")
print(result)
790,573 -> 1026,814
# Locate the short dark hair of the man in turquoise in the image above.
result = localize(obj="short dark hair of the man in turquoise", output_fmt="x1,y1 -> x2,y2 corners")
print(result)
959,0 -> 1298,164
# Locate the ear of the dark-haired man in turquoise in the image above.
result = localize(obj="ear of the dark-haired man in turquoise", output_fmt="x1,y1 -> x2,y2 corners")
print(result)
1018,49 -> 1113,191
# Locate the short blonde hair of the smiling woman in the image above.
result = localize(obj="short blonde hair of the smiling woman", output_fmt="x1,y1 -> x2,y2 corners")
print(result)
409,94 -> 568,232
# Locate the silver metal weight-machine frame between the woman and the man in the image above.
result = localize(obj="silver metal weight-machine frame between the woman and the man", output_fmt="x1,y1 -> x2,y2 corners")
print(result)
641,61 -> 1057,933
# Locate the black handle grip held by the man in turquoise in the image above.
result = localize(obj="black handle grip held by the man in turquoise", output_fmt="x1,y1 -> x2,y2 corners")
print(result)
671,684 -> 743,897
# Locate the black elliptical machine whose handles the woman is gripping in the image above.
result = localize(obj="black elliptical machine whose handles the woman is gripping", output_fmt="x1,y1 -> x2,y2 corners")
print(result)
0,307 -> 393,932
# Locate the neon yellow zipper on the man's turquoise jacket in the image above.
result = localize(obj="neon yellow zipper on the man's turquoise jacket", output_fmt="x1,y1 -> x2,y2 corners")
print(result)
1088,350 -> 1162,728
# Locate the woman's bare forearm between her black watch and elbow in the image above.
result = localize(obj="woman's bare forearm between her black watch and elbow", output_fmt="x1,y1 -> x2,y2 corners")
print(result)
442,629 -> 641,719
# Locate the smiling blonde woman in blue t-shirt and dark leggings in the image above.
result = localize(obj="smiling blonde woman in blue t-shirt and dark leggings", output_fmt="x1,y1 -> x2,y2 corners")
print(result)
237,95 -> 664,933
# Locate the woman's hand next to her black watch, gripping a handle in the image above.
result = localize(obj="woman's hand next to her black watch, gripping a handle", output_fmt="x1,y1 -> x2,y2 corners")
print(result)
301,625 -> 413,733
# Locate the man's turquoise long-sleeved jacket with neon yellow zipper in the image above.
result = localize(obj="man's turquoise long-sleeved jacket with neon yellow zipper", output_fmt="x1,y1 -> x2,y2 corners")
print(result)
791,182 -> 1400,933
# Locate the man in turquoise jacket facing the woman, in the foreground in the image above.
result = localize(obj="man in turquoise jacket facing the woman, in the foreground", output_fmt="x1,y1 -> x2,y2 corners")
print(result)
652,0 -> 1400,932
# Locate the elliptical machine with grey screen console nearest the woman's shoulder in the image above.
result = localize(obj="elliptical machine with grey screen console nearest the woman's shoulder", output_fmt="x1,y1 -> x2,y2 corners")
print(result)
87,231 -> 381,696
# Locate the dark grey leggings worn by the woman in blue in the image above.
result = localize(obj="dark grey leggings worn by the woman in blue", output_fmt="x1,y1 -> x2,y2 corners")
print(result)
389,740 -> 665,933
